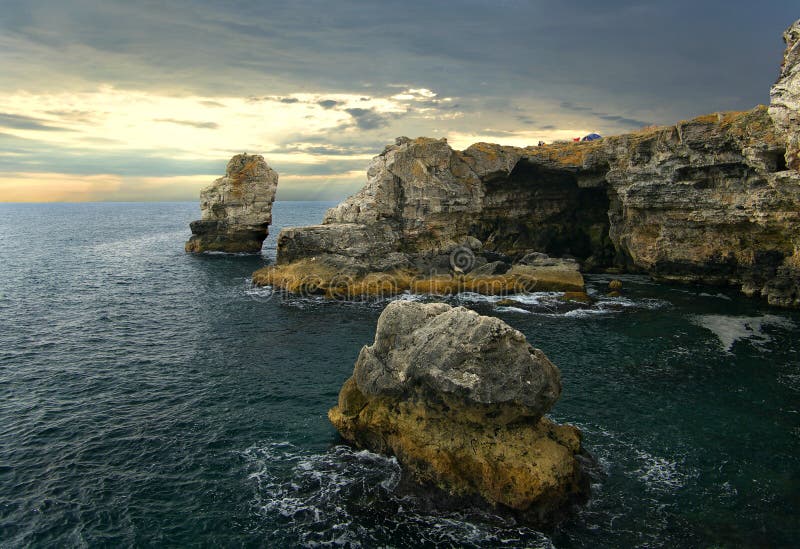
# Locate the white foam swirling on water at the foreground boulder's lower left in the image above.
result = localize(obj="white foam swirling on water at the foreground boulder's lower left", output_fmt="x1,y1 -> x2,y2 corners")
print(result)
241,442 -> 553,548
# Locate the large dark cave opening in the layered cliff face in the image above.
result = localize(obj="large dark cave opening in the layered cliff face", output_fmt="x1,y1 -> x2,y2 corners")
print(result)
473,160 -> 615,269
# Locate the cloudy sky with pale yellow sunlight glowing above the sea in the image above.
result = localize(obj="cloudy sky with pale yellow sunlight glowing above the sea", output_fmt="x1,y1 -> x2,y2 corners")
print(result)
0,0 -> 800,202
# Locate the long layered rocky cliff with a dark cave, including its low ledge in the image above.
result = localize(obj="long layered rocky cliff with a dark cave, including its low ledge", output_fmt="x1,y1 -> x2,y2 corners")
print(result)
254,22 -> 800,307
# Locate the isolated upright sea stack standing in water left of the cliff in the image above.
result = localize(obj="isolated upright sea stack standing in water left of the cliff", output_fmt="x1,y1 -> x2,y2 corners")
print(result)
186,154 -> 278,253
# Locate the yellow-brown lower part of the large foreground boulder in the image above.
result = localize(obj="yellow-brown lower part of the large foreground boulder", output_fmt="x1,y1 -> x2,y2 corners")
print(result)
328,378 -> 586,520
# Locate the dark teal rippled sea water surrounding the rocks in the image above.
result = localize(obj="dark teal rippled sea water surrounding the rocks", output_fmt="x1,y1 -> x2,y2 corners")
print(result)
0,202 -> 800,547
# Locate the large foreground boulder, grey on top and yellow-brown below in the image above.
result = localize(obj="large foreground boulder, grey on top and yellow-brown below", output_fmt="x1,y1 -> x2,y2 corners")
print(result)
328,301 -> 588,522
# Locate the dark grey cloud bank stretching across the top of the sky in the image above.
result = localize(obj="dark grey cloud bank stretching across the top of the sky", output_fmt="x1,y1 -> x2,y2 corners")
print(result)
0,0 -> 798,114
